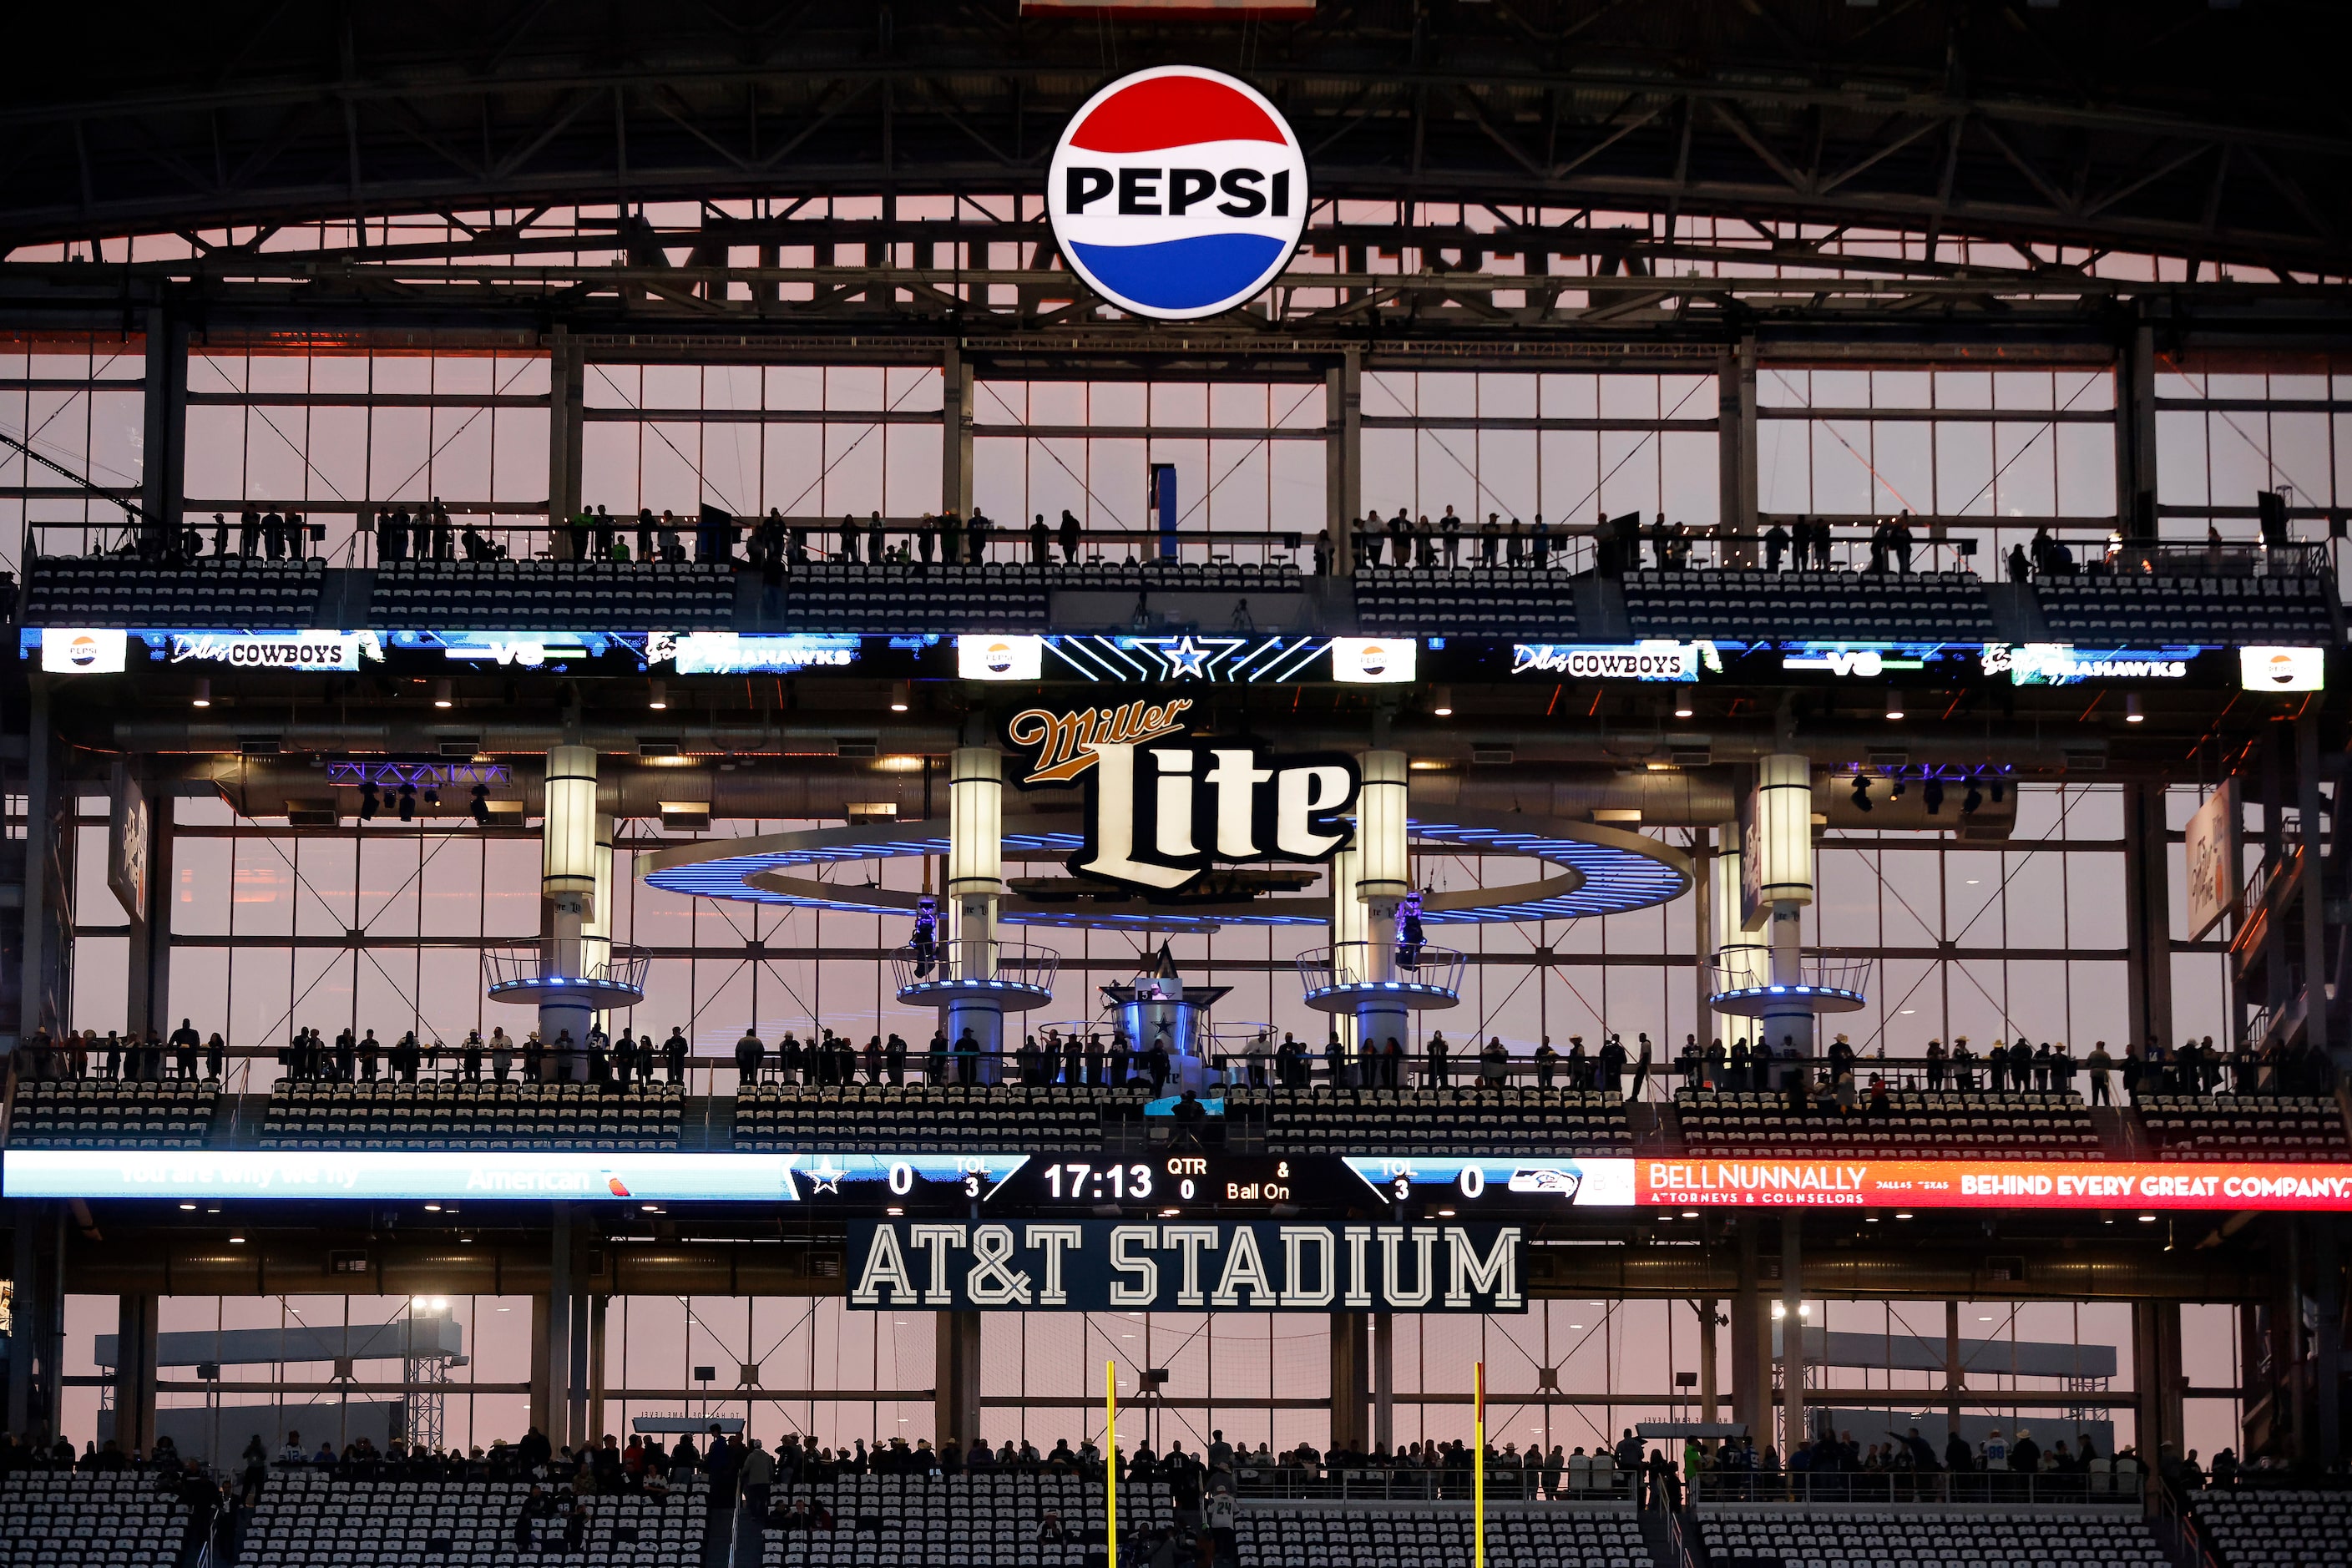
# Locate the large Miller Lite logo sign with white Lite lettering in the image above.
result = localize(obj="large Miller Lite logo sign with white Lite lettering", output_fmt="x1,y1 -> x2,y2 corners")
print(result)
1004,698 -> 1359,898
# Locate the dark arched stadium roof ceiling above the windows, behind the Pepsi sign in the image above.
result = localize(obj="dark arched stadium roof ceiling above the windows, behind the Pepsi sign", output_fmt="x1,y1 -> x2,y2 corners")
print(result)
0,0 -> 2352,277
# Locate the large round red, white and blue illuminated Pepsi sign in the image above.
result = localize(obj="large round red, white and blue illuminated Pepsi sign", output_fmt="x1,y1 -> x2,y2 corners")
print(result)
1047,66 -> 1308,322
